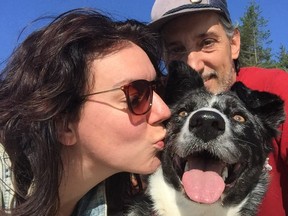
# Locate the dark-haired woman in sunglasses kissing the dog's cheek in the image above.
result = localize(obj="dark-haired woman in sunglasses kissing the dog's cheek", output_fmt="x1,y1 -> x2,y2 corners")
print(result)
0,9 -> 170,216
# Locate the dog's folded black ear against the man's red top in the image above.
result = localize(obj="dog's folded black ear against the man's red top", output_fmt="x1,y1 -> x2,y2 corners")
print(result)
231,82 -> 285,131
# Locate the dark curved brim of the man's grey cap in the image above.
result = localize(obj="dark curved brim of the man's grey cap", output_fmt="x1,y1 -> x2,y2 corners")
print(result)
148,8 -> 221,31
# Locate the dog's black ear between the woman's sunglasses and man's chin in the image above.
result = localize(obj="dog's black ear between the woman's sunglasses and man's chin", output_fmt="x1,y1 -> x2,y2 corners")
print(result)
164,61 -> 204,105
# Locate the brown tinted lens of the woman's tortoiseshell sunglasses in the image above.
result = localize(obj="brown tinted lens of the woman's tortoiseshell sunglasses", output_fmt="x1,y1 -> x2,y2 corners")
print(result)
128,80 -> 153,115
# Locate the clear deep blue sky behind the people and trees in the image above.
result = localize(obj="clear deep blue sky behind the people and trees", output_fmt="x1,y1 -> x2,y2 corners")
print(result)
0,0 -> 288,68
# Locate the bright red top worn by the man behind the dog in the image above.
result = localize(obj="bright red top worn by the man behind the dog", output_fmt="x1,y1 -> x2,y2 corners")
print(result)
237,67 -> 288,216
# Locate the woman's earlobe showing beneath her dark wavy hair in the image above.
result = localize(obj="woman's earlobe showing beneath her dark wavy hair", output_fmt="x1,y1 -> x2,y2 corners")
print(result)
57,121 -> 77,146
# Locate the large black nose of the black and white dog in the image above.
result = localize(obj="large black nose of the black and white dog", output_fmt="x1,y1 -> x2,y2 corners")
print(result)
189,110 -> 225,142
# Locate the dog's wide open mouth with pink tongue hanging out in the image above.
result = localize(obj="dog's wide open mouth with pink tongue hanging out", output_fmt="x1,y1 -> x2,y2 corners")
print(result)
173,151 -> 245,204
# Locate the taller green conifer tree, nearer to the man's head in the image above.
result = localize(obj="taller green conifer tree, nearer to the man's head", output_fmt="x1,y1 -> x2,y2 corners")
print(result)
239,1 -> 273,67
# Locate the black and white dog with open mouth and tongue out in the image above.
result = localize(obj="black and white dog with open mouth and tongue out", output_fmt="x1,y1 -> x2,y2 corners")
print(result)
128,62 -> 285,216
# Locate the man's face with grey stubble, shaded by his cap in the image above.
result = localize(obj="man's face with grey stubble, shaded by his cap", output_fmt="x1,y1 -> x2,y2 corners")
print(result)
161,12 -> 240,93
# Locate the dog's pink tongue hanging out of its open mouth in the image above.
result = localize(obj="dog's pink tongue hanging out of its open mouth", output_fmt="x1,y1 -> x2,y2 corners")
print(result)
182,159 -> 225,204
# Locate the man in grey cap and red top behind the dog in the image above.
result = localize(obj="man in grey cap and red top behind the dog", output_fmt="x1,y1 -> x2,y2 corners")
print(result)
150,0 -> 288,216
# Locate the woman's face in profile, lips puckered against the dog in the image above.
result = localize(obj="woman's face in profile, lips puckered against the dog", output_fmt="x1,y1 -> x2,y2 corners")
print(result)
66,43 -> 170,180
